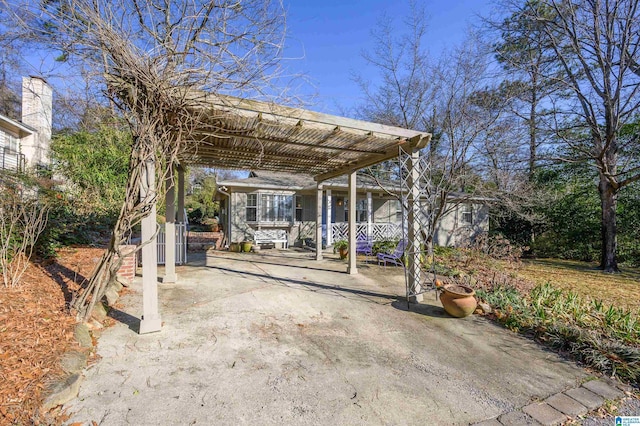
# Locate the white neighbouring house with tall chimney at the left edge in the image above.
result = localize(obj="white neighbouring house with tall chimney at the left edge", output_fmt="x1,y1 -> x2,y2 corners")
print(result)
0,77 -> 52,170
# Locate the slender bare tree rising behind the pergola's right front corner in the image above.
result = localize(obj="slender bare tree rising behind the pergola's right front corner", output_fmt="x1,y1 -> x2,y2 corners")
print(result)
356,3 -> 501,256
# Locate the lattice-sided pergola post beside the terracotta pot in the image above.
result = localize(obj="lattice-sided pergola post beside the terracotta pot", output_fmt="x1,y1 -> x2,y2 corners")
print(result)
406,149 -> 424,303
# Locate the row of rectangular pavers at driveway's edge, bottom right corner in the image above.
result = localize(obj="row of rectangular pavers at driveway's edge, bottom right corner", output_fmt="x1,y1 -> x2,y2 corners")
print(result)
474,378 -> 633,426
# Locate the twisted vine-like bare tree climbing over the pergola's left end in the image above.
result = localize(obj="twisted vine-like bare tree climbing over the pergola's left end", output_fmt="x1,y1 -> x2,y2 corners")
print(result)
2,0 -> 285,320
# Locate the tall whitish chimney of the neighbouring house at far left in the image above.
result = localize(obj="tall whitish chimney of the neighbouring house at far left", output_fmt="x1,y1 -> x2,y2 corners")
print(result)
20,77 -> 53,167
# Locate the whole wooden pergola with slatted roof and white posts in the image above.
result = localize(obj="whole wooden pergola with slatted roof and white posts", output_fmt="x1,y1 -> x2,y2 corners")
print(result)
140,94 -> 431,333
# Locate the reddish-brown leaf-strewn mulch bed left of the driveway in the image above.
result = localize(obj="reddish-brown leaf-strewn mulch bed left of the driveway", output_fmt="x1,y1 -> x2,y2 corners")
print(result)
0,248 -> 103,425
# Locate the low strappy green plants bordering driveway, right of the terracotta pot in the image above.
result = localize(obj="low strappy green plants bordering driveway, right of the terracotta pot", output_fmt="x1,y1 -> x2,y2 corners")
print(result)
477,283 -> 640,384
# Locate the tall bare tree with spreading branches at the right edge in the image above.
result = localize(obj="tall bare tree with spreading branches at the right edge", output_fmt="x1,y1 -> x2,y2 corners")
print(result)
517,0 -> 640,272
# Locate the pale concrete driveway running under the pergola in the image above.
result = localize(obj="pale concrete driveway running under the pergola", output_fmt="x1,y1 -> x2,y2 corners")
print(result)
65,250 -> 587,425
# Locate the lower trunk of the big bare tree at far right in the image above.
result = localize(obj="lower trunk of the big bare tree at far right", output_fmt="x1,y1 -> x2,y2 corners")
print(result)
598,173 -> 620,273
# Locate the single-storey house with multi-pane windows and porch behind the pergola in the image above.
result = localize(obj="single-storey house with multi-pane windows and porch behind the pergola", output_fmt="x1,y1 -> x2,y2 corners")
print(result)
218,171 -> 489,246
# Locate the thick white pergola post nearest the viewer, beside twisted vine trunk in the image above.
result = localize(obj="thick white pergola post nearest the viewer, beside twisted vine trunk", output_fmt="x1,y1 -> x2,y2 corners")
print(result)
140,161 -> 162,334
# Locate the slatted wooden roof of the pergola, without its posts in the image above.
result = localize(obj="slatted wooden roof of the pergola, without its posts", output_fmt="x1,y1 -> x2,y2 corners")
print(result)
182,94 -> 431,181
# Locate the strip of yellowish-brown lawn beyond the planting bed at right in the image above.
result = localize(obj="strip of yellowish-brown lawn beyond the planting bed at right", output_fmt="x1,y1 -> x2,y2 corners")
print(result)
518,259 -> 640,311
